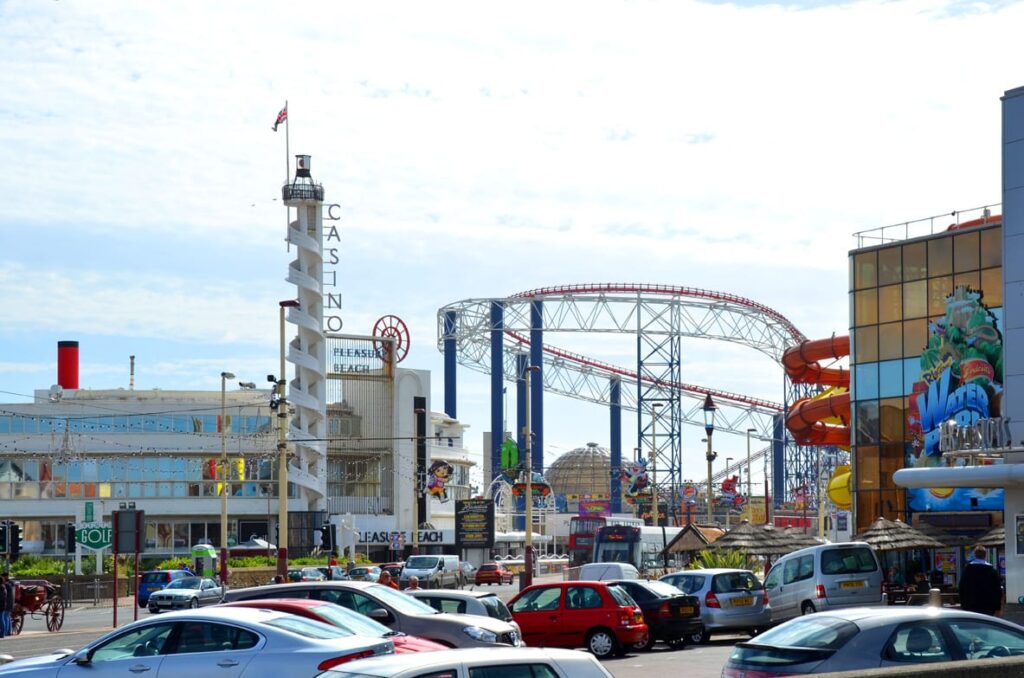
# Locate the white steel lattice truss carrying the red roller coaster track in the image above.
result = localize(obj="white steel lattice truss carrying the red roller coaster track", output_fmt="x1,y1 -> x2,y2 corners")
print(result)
437,284 -> 805,501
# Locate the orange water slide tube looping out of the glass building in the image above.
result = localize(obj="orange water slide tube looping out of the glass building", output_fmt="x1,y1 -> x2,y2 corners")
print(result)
782,335 -> 850,448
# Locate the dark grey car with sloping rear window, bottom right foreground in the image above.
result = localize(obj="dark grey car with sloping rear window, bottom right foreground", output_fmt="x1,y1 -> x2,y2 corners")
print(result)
722,606 -> 1024,678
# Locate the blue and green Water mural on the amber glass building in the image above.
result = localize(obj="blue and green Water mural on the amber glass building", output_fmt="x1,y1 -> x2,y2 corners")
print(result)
906,287 -> 1002,511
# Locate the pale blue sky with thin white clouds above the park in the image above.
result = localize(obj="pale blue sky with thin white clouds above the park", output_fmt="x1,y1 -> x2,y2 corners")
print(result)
0,0 -> 1024,499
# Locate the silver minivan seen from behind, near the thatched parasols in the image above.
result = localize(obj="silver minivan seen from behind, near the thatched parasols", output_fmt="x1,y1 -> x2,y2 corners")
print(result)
765,542 -> 885,624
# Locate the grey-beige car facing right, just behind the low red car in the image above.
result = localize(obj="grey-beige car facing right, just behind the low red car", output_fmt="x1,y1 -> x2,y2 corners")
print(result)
225,582 -> 521,647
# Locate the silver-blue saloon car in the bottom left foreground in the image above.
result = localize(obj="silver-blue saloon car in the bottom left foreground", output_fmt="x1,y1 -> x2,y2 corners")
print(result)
0,607 -> 394,678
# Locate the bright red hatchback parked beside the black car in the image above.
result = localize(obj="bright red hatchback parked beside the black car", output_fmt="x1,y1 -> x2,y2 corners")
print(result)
509,582 -> 647,659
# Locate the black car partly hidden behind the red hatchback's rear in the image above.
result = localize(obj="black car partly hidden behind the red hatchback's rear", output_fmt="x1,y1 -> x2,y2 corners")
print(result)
608,579 -> 700,650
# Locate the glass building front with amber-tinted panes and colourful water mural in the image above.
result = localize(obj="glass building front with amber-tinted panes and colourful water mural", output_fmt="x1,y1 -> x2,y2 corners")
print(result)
850,208 -> 1004,537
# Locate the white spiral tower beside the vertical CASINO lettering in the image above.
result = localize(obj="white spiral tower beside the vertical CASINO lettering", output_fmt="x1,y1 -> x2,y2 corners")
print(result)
282,156 -> 327,510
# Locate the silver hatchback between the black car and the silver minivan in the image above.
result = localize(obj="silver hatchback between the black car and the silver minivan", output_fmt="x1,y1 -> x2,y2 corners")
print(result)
660,568 -> 771,643
